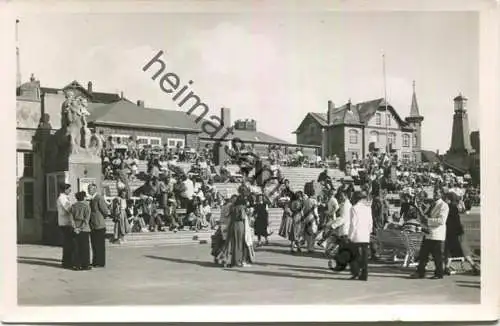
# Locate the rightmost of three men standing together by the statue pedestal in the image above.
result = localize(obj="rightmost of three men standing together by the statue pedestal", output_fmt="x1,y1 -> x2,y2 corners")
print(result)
88,184 -> 110,267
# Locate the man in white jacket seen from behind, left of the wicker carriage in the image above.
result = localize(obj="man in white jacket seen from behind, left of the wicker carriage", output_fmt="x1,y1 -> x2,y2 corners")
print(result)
348,191 -> 373,281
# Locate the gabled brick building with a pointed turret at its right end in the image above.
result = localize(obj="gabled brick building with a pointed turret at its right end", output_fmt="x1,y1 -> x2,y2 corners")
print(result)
294,84 -> 424,163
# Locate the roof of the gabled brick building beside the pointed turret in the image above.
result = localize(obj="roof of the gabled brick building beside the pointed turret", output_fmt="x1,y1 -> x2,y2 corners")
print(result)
295,98 -> 408,133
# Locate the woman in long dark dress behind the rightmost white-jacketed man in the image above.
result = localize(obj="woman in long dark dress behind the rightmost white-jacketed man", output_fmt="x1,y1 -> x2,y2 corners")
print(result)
444,192 -> 479,275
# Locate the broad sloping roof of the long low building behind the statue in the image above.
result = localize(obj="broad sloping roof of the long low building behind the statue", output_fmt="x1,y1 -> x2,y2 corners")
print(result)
87,99 -> 201,132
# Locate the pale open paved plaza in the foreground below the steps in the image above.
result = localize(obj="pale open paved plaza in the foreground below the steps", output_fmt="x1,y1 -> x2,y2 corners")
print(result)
18,243 -> 480,305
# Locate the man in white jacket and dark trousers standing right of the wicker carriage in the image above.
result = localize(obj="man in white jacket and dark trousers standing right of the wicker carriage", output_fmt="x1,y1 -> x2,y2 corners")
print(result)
411,187 -> 450,279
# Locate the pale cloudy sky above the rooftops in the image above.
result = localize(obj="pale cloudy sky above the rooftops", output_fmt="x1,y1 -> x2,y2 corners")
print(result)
19,12 -> 479,151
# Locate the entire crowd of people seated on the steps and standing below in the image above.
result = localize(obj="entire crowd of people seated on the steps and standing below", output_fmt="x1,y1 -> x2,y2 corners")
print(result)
58,131 -> 480,280
